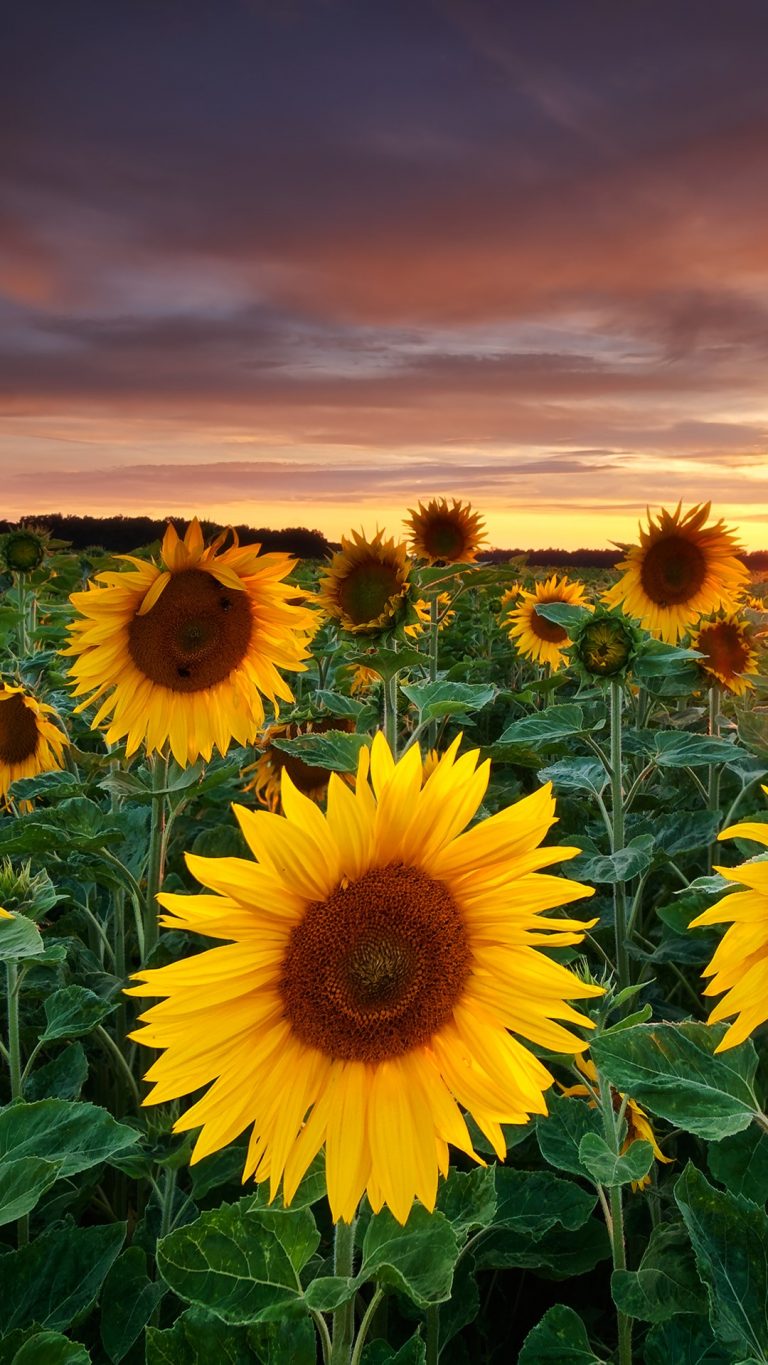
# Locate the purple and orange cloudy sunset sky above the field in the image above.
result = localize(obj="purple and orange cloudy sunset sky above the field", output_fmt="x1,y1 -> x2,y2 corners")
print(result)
0,0 -> 768,549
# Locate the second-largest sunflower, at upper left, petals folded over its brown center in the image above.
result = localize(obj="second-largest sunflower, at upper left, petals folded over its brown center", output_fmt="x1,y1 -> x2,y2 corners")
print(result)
64,519 -> 314,766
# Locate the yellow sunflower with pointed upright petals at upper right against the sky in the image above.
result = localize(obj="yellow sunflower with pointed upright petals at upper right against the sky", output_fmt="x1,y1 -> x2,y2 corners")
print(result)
604,502 -> 749,644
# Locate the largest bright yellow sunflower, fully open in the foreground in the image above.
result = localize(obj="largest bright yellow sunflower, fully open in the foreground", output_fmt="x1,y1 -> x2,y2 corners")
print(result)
132,733 -> 602,1223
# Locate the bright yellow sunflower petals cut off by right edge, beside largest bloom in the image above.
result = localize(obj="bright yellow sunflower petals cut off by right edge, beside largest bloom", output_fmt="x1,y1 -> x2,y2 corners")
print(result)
689,786 -> 768,1052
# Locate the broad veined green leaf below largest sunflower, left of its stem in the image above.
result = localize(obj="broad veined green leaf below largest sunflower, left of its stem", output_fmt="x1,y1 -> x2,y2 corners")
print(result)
157,1200 -> 301,1324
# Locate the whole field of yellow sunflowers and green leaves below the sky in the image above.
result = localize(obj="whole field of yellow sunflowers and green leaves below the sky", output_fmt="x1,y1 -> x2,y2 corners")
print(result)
0,500 -> 768,1365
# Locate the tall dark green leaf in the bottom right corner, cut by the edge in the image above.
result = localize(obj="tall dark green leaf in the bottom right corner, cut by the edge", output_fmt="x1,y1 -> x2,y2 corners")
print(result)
675,1163 -> 768,1361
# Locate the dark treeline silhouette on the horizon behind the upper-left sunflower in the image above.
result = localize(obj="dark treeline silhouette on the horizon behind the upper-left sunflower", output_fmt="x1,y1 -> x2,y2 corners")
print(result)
0,512 -> 331,560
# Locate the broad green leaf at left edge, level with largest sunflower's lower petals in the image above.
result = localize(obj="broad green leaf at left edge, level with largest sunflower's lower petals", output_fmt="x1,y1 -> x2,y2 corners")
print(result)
0,1100 -> 139,1175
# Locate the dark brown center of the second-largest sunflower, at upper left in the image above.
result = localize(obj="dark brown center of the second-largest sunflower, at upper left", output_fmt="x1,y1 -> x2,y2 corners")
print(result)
128,569 -> 252,692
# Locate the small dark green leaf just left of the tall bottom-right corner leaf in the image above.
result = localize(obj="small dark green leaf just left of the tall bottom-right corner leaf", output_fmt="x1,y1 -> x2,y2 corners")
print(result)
611,1223 -> 707,1323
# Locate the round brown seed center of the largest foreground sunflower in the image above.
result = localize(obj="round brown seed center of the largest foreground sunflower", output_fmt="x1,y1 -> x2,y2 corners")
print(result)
281,864 -> 471,1062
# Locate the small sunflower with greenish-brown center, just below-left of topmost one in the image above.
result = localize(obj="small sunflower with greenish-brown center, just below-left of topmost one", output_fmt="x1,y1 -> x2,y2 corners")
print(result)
318,531 -> 411,635
